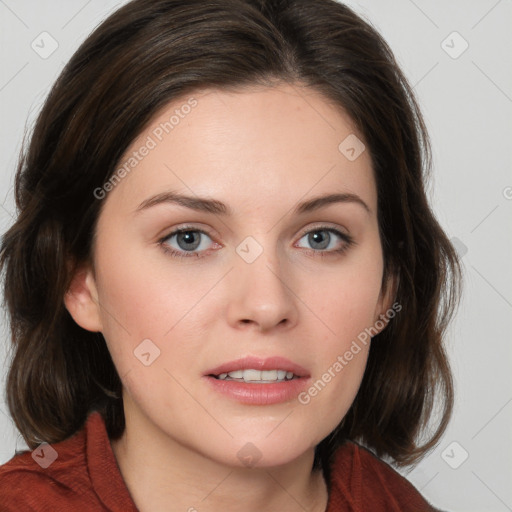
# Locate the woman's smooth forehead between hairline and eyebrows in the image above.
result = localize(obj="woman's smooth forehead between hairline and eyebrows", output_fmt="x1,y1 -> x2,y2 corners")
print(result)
102,84 -> 376,215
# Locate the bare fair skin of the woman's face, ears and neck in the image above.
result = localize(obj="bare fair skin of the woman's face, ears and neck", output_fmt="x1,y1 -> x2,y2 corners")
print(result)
65,84 -> 392,512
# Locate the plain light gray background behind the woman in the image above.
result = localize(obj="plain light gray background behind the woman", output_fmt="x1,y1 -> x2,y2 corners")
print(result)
0,0 -> 512,512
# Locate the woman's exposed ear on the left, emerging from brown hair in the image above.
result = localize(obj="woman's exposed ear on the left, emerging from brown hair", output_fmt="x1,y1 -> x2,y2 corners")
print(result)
64,265 -> 103,332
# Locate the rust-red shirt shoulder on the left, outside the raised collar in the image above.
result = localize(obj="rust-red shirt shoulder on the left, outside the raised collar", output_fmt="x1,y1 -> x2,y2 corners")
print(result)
0,413 -> 111,512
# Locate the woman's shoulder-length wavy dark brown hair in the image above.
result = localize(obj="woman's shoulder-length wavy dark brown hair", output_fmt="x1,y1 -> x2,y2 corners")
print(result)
0,0 -> 461,476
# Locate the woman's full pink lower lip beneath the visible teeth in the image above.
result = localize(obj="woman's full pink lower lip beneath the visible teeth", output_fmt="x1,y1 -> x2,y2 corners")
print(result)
205,376 -> 310,405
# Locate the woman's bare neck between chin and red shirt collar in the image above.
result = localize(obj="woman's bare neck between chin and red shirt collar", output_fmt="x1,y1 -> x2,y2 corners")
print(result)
111,404 -> 328,512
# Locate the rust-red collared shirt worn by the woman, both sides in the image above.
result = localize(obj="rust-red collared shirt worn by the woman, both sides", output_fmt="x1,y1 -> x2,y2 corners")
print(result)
0,412 -> 436,512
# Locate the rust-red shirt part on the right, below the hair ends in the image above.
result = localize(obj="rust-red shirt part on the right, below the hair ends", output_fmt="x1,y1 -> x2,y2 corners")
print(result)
328,442 -> 444,512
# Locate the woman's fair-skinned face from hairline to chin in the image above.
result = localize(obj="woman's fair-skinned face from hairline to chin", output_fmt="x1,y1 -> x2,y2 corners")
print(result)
71,85 -> 389,466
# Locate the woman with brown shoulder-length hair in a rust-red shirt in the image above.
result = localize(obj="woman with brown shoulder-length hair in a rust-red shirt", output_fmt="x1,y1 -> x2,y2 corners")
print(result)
0,0 -> 460,512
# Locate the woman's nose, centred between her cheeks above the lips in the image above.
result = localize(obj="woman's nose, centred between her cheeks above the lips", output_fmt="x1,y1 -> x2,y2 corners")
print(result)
228,242 -> 299,332
